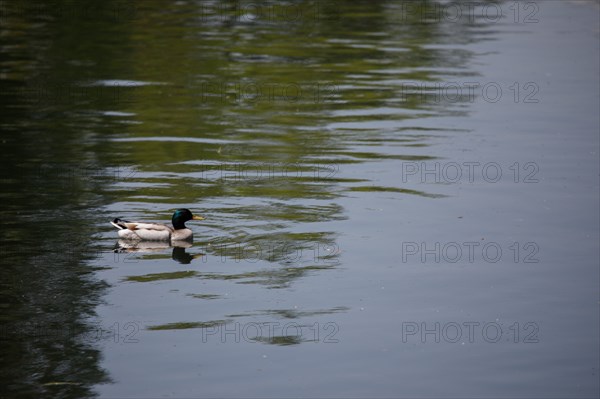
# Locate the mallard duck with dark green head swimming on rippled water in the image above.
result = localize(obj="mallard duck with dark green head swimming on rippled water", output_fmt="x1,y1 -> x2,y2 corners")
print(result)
110,209 -> 204,241
